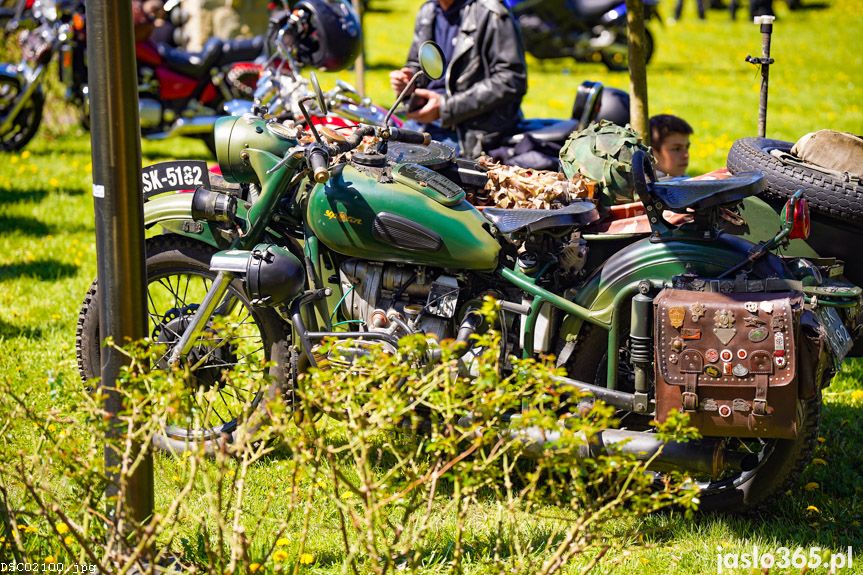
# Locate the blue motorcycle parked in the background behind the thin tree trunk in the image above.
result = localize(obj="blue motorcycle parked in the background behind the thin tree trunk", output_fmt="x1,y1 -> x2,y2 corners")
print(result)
506,0 -> 659,71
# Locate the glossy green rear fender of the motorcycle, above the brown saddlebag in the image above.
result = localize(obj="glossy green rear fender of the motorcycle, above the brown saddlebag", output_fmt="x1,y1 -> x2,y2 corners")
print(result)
560,233 -> 791,337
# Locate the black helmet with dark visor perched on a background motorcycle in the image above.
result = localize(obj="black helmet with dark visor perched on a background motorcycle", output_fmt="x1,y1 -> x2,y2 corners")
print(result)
293,0 -> 361,70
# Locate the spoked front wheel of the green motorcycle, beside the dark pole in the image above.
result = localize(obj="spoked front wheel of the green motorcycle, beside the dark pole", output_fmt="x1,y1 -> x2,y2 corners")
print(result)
77,236 -> 288,451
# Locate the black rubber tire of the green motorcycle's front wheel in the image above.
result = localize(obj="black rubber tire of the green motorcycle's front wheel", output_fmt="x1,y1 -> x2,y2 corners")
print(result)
75,234 -> 290,453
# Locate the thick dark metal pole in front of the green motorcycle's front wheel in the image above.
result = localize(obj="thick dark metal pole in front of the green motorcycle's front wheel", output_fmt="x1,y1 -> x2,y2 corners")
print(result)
87,0 -> 153,522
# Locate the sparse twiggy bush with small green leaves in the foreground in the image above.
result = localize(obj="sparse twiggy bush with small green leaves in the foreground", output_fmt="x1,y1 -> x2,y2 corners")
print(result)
0,305 -> 697,574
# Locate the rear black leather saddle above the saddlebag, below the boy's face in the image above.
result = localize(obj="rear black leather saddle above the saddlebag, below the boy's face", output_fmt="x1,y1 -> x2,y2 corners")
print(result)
651,172 -> 764,214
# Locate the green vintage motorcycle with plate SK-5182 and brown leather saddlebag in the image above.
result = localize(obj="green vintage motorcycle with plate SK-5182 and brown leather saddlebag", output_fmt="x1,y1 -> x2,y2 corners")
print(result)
78,44 -> 861,509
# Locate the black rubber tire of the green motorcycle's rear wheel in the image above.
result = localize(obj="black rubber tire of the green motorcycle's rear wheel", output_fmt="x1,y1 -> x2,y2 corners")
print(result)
570,324 -> 821,513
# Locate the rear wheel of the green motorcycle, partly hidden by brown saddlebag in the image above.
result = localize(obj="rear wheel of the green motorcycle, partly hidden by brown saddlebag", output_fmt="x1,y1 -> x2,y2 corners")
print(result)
567,326 -> 821,512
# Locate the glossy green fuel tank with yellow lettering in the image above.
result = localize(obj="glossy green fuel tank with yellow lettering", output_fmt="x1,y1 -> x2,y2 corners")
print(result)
306,164 -> 500,271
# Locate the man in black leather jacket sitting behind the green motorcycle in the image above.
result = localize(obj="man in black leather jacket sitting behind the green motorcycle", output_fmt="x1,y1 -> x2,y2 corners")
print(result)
390,0 -> 527,158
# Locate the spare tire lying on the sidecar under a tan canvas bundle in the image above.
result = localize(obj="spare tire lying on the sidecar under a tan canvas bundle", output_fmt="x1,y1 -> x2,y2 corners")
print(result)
727,138 -> 863,223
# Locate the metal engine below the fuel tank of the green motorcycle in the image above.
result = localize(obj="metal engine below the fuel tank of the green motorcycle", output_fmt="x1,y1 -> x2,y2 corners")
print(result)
340,259 -> 460,341
